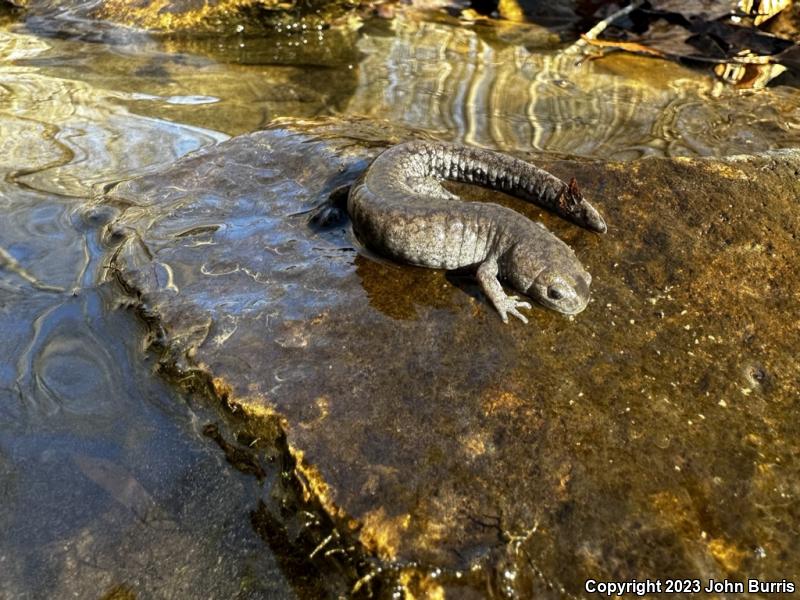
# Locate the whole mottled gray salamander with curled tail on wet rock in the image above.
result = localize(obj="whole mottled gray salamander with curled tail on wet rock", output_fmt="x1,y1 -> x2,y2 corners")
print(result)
347,142 -> 606,323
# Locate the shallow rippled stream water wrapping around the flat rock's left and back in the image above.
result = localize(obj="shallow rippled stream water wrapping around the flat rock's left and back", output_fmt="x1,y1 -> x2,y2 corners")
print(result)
0,3 -> 800,598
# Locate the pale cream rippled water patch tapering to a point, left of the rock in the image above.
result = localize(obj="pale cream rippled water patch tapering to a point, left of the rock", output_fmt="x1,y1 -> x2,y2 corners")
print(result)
0,31 -> 227,197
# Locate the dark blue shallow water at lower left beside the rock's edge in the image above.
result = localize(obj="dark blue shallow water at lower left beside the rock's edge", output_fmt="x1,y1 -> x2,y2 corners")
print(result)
0,289 -> 294,598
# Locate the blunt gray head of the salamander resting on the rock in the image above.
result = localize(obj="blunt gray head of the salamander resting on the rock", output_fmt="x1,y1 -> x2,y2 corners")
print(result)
504,244 -> 592,315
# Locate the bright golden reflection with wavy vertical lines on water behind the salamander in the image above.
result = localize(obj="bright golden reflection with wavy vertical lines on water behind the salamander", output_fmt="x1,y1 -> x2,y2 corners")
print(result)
346,19 -> 800,159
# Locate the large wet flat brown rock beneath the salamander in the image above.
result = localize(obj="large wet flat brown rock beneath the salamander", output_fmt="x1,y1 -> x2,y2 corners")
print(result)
106,116 -> 800,597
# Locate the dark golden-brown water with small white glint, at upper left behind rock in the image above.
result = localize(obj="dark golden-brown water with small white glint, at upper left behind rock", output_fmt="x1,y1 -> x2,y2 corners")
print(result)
11,23 -> 359,134
